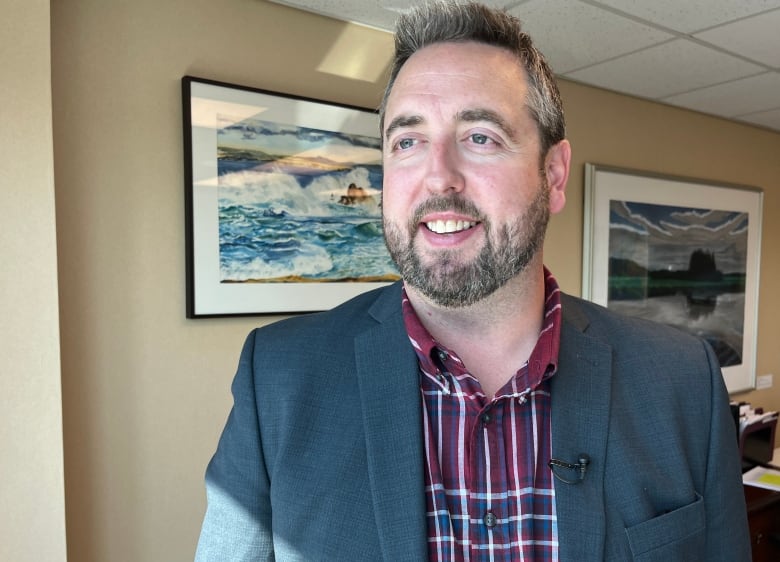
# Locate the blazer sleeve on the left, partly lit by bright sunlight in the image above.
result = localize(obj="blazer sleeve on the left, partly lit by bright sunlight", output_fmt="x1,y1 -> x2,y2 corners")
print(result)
195,331 -> 274,562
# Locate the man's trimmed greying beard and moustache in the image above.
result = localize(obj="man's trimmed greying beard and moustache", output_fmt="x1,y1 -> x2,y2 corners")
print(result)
383,179 -> 550,308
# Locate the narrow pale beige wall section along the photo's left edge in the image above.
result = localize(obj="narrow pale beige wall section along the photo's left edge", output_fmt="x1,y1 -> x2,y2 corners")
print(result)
0,0 -> 65,562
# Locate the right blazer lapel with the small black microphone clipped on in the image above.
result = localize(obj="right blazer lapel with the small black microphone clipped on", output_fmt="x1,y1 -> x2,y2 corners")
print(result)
551,300 -> 612,562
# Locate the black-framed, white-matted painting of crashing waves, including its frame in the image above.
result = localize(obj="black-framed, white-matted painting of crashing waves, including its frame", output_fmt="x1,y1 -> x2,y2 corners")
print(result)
182,76 -> 398,318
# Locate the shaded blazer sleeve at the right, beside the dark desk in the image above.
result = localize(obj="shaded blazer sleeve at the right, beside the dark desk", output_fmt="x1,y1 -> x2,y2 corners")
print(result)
703,344 -> 750,562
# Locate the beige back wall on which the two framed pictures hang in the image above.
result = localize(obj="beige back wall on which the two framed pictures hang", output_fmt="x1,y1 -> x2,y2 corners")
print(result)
52,0 -> 780,562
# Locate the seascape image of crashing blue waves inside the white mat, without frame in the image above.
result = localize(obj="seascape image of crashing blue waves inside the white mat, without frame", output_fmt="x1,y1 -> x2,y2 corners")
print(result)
216,115 -> 398,283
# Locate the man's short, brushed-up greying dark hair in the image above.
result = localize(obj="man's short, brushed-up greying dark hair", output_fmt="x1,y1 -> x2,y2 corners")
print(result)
379,0 -> 566,156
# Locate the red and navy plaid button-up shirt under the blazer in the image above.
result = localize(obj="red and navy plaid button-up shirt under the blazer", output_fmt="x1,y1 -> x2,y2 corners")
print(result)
403,269 -> 561,562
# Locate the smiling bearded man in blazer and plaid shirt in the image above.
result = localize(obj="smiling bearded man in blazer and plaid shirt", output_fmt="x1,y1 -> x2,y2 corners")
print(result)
197,3 -> 749,562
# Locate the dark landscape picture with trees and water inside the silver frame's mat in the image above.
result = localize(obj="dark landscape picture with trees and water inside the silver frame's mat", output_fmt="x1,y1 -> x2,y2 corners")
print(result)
607,199 -> 750,367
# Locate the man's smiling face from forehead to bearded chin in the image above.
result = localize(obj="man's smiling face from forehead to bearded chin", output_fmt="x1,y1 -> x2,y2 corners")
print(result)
382,42 -> 568,307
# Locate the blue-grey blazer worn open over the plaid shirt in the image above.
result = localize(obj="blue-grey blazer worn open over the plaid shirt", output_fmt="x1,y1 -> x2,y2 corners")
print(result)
196,284 -> 750,562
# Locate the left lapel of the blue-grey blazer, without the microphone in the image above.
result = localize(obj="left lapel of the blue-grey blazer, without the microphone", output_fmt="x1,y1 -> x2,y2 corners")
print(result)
355,290 -> 427,562
